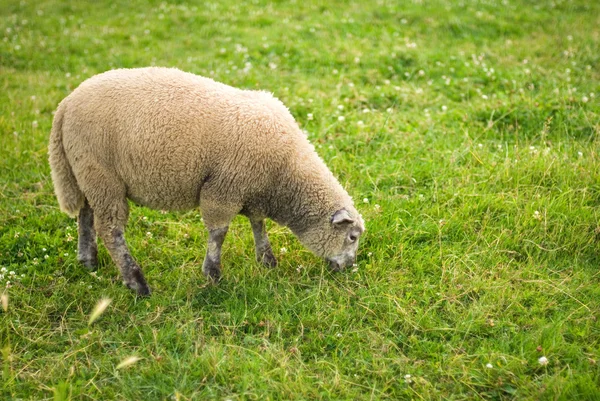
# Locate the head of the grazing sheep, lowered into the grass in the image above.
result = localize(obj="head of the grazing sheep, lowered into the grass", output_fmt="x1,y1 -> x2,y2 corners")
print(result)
298,207 -> 365,271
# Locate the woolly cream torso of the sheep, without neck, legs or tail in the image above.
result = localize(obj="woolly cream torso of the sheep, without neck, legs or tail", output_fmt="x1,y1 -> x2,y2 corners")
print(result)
63,68 -> 298,209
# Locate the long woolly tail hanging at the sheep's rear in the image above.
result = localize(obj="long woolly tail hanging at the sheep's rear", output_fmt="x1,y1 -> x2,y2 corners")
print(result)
48,103 -> 85,216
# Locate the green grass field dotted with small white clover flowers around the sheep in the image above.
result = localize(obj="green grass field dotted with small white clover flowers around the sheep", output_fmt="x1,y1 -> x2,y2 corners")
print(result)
0,0 -> 600,400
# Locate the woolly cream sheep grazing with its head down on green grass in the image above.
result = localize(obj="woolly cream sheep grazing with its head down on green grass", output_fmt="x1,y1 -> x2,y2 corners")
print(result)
48,67 -> 365,296
